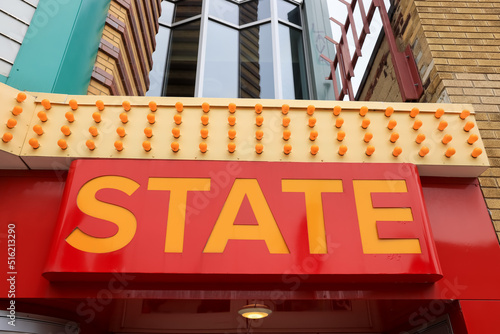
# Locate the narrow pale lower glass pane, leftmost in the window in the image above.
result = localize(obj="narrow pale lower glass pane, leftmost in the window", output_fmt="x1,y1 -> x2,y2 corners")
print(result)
146,26 -> 170,96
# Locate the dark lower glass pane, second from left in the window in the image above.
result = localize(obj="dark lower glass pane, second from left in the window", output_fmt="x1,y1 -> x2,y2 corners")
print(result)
166,20 -> 200,97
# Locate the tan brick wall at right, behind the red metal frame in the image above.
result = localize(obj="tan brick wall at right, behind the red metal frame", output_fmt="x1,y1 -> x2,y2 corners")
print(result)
361,0 -> 500,238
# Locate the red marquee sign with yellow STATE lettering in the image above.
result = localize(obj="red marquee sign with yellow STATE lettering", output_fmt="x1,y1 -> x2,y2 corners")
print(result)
44,160 -> 442,282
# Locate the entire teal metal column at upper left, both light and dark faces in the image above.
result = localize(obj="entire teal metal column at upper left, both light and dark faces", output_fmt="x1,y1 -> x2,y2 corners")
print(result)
6,0 -> 110,94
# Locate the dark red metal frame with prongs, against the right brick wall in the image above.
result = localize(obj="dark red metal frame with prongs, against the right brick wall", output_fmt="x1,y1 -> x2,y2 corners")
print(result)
321,0 -> 424,102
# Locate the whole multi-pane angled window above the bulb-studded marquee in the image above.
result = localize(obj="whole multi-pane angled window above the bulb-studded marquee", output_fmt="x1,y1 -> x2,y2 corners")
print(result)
147,0 -> 309,99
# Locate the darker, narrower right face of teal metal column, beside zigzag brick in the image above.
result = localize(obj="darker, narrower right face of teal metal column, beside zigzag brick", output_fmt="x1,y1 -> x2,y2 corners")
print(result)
52,0 -> 111,95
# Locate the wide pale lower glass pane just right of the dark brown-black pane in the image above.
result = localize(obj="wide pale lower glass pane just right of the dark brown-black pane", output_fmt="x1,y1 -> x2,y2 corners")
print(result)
203,21 -> 238,98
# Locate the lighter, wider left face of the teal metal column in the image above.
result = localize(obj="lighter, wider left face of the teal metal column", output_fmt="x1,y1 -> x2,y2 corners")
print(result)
7,0 -> 85,93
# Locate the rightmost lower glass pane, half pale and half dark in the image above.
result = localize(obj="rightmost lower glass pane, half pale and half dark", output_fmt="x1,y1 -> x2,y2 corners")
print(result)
279,24 -> 309,99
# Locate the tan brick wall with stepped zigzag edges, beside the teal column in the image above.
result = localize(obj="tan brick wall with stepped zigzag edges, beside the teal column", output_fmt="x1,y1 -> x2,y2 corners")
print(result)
88,0 -> 161,96
